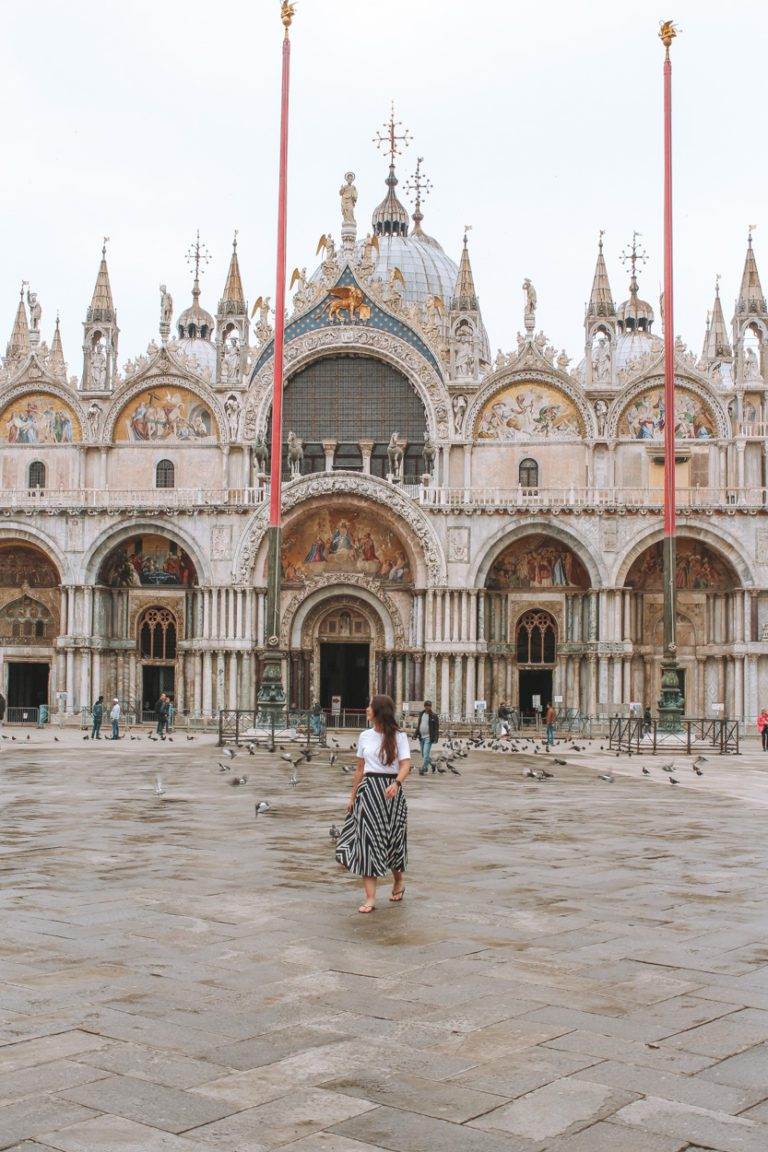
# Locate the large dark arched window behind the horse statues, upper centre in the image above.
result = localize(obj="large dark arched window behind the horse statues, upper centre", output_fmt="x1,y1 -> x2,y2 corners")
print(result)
267,355 -> 426,482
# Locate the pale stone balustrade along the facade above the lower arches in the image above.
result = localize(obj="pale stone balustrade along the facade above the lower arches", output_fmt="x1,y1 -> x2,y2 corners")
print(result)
0,484 -> 768,511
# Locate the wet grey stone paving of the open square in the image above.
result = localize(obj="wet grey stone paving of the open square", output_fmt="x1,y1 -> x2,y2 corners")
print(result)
0,732 -> 768,1152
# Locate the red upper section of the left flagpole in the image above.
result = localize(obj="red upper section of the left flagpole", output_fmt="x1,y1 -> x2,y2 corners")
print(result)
269,3 -> 294,528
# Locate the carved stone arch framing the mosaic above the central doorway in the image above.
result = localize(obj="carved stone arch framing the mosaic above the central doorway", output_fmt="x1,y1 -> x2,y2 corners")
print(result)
233,472 -> 447,588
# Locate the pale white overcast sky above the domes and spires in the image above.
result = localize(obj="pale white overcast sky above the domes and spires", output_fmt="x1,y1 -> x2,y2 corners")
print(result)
0,0 -> 768,376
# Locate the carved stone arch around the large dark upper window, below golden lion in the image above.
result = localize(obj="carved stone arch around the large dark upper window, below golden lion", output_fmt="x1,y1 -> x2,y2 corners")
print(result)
244,325 -> 450,441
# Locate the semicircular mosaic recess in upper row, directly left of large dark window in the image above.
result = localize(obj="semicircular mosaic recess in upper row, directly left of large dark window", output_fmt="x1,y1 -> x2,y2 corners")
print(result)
102,374 -> 229,447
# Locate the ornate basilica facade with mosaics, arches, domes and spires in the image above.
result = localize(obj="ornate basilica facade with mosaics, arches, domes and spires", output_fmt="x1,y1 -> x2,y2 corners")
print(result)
0,141 -> 768,721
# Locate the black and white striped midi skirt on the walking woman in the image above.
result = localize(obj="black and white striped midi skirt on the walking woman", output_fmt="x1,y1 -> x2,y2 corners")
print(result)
336,773 -> 408,877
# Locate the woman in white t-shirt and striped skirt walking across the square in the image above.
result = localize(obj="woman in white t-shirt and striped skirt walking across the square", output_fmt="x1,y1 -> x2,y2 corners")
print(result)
336,696 -> 411,912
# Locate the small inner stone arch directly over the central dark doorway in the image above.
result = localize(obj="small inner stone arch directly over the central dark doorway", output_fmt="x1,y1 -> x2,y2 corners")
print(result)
281,576 -> 405,651
